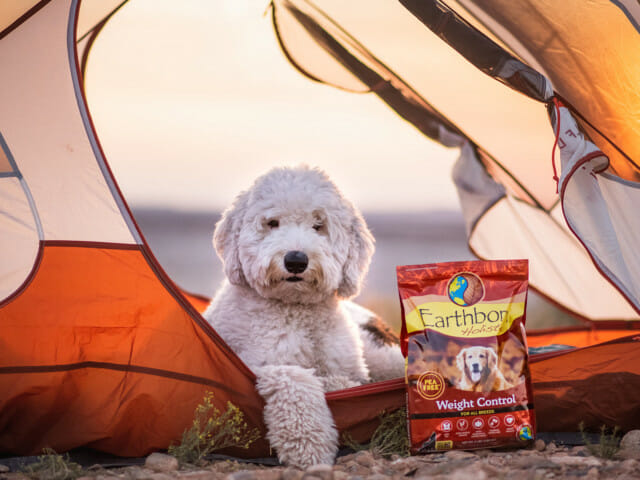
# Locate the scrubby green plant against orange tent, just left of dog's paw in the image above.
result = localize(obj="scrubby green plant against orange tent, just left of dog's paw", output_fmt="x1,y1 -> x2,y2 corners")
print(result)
169,392 -> 260,465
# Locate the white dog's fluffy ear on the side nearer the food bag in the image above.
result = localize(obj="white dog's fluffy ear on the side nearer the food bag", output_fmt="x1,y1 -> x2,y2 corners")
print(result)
338,209 -> 374,298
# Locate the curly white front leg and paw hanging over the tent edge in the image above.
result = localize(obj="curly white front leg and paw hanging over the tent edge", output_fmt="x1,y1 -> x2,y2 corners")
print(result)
254,366 -> 338,468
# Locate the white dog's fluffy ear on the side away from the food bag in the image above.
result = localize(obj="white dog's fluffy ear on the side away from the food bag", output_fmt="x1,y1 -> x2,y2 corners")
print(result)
213,188 -> 249,285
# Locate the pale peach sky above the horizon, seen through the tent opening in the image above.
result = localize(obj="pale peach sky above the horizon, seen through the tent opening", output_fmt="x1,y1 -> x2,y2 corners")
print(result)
86,0 -> 459,212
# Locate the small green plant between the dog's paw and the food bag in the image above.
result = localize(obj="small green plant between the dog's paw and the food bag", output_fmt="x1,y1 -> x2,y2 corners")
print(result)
342,408 -> 409,457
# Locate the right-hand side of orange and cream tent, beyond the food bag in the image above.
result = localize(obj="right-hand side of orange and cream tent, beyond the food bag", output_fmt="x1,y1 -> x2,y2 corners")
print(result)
272,0 -> 640,431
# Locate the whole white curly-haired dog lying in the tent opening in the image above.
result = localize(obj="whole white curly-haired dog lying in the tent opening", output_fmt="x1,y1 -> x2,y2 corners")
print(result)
204,166 -> 404,468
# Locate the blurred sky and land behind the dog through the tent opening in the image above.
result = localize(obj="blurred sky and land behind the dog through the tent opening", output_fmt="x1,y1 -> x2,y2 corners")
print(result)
86,0 -> 574,328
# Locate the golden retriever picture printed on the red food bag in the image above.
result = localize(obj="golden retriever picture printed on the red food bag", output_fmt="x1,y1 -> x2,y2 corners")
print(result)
456,346 -> 513,393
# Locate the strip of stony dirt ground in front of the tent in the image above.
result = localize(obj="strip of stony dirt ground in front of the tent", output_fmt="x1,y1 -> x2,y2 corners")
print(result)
0,430 -> 640,480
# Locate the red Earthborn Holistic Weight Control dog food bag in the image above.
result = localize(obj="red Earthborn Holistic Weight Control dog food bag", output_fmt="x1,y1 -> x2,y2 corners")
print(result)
397,260 -> 535,454
